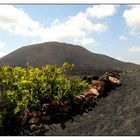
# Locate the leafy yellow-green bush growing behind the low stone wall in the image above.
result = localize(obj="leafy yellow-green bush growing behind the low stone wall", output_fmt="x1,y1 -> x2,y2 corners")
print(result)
0,62 -> 89,126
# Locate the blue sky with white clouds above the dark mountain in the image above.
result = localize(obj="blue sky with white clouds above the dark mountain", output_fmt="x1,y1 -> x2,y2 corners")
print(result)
0,4 -> 140,64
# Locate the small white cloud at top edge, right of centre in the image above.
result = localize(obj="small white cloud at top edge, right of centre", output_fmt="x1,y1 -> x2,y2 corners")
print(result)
86,5 -> 116,19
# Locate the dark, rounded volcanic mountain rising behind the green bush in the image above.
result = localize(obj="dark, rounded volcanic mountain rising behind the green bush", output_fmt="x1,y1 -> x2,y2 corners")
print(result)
0,42 -> 140,74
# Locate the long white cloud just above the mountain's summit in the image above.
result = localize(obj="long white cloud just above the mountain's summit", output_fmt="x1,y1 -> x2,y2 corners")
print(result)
40,13 -> 107,41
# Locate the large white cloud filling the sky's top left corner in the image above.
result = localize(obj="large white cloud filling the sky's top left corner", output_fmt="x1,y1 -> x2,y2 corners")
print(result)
0,5 -> 40,36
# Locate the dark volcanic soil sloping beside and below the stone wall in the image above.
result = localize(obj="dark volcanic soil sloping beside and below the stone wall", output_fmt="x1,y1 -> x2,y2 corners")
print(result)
0,72 -> 140,136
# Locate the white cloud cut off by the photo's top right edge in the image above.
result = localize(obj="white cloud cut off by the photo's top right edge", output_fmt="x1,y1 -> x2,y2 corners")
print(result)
123,5 -> 140,34
